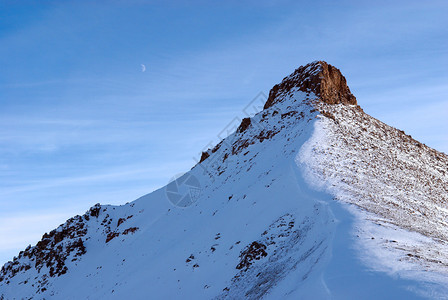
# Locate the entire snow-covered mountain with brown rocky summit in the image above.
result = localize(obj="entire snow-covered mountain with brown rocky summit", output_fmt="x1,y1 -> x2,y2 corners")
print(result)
0,61 -> 448,299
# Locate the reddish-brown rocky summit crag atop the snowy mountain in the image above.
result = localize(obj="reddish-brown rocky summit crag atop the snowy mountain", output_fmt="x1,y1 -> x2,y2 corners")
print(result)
264,61 -> 357,109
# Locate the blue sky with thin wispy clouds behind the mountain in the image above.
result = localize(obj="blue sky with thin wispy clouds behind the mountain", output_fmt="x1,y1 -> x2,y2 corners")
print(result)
0,1 -> 448,264
